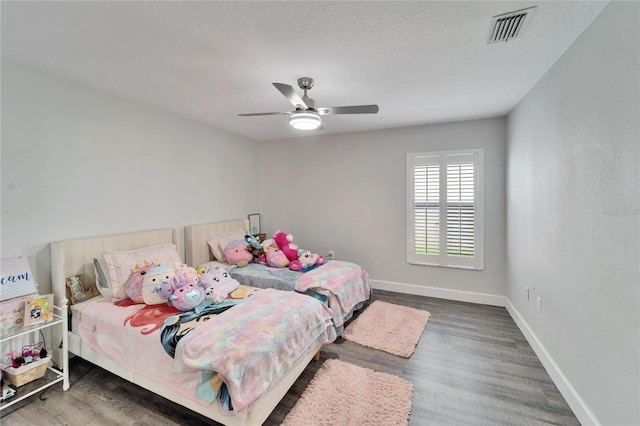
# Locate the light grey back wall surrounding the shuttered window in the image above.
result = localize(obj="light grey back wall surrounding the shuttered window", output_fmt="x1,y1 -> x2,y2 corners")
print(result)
260,118 -> 506,304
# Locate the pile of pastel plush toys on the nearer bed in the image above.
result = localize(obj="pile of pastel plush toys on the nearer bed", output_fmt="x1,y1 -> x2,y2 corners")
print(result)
126,262 -> 240,311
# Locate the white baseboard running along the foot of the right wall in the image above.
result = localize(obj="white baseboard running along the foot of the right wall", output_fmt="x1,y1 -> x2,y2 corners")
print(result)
505,298 -> 601,426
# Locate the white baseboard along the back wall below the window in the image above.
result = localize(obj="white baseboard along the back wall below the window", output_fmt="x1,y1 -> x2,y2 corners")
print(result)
371,280 -> 506,306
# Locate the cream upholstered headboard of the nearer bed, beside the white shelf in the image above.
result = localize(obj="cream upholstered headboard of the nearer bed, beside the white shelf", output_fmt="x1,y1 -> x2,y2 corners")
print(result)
51,229 -> 178,308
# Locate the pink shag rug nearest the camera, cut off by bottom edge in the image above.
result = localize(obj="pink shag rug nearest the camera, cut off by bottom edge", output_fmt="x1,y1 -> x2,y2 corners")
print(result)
282,359 -> 413,426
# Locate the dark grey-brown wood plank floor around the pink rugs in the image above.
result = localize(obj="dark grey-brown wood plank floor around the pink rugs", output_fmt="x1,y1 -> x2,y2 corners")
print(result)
0,291 -> 580,426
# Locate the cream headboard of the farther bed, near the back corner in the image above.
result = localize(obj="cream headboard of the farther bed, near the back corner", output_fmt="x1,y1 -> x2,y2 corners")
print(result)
184,219 -> 249,268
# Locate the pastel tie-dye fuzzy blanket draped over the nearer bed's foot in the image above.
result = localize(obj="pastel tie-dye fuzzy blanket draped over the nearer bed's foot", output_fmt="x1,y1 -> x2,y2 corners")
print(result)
176,289 -> 336,416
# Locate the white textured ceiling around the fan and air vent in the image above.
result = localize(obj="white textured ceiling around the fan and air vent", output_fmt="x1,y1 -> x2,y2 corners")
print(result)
0,1 -> 606,140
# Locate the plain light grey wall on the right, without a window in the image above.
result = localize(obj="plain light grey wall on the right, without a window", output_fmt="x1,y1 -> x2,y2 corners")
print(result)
507,2 -> 640,425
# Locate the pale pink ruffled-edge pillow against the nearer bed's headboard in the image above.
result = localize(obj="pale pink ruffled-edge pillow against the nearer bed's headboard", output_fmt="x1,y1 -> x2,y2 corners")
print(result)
102,243 -> 182,299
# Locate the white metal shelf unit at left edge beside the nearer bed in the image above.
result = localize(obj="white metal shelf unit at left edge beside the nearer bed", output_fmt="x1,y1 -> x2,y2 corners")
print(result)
0,300 -> 69,411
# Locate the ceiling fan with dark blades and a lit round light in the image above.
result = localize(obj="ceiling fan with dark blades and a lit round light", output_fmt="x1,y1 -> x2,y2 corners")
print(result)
238,77 -> 379,130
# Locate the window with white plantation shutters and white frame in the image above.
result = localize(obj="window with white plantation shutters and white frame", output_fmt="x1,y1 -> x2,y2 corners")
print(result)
407,149 -> 484,269
